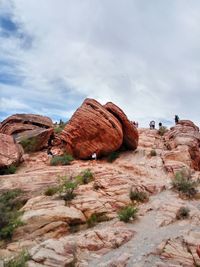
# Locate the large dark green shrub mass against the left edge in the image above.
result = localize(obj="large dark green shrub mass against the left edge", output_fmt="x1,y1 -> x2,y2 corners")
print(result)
0,189 -> 24,240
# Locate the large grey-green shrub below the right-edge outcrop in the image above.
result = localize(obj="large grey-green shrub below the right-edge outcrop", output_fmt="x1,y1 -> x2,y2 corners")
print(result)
172,171 -> 198,197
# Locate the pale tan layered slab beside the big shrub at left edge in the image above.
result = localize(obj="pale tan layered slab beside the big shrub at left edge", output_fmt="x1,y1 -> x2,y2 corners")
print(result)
14,196 -> 85,243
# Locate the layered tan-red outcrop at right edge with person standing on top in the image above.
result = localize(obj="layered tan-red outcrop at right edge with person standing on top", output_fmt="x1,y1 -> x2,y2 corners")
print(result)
162,120 -> 200,170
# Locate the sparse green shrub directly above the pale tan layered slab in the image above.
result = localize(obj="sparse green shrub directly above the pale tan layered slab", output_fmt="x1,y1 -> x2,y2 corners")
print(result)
59,176 -> 78,201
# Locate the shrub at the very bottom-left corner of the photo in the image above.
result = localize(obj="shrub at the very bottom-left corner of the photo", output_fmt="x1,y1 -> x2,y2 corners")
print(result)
4,250 -> 30,267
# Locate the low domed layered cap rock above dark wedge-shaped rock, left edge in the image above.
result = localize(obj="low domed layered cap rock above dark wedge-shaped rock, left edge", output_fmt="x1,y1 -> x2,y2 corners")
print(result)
0,114 -> 53,135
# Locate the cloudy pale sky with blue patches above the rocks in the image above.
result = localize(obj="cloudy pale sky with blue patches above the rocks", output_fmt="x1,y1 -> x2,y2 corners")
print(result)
0,0 -> 200,125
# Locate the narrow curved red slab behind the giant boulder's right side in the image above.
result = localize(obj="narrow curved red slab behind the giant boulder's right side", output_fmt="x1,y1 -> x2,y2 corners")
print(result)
104,102 -> 139,150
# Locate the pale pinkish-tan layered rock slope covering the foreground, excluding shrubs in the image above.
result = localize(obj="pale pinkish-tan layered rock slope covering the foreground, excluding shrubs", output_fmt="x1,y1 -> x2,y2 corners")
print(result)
0,121 -> 200,267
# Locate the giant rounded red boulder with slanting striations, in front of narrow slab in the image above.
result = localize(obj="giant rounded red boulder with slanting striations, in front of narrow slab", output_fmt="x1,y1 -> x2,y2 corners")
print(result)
61,99 -> 123,159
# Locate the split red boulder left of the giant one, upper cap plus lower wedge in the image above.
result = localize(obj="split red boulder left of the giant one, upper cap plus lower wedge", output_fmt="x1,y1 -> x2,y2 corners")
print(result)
0,114 -> 53,152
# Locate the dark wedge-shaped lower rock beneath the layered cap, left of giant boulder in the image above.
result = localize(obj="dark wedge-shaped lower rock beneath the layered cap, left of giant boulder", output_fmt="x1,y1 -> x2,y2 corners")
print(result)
15,128 -> 53,152
